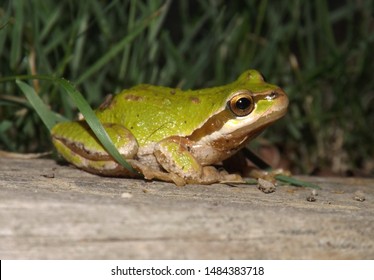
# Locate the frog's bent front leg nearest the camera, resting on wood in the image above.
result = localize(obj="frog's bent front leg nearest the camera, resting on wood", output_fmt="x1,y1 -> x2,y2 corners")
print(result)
154,136 -> 241,184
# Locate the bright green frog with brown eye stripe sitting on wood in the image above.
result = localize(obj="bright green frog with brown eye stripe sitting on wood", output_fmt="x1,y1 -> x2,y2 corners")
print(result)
51,69 -> 288,186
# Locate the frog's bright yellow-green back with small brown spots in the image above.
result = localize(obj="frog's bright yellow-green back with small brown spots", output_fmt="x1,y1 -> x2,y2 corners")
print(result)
96,84 -> 231,144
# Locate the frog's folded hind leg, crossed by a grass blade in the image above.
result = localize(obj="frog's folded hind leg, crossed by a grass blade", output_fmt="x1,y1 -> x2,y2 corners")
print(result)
51,121 -> 138,177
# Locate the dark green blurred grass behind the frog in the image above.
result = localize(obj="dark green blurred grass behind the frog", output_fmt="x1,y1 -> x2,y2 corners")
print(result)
0,0 -> 374,175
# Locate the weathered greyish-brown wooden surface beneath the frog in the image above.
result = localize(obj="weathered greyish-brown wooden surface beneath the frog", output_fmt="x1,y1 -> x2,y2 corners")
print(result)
0,158 -> 374,259
